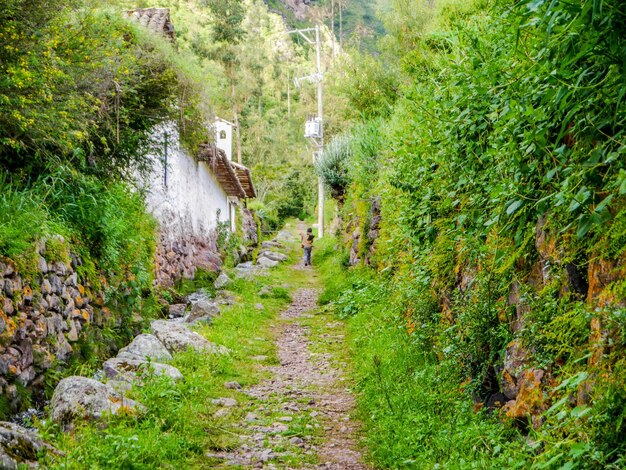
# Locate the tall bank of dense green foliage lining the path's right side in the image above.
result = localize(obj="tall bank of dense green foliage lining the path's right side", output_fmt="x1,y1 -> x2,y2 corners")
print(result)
322,1 -> 626,468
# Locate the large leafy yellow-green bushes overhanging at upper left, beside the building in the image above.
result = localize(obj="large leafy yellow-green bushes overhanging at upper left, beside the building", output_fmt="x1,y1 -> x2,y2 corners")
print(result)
0,0 -> 207,177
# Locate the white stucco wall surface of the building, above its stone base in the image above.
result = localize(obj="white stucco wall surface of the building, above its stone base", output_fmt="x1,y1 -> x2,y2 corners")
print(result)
144,128 -> 230,241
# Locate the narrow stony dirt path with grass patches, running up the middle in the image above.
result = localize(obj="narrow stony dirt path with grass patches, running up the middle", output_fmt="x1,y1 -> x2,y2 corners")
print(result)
211,289 -> 368,470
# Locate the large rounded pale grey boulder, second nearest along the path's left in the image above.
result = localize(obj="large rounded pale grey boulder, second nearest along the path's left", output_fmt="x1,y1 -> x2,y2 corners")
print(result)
50,376 -> 141,425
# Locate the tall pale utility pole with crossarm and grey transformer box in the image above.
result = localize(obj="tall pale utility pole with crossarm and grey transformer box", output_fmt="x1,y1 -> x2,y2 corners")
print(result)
288,25 -> 324,238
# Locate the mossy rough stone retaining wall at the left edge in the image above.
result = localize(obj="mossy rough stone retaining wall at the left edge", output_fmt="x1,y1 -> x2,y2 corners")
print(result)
0,249 -> 108,411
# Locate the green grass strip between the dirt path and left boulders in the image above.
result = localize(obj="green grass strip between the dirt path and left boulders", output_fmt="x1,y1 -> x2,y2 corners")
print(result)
36,268 -> 287,468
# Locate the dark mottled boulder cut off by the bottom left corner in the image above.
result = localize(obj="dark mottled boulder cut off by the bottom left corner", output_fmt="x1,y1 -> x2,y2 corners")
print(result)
0,421 -> 59,470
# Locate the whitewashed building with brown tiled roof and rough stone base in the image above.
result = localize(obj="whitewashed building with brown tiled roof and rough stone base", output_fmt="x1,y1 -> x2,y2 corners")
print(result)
127,8 -> 256,284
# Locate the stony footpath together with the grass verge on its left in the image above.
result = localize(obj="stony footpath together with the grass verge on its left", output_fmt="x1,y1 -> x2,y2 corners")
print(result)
42,222 -> 363,469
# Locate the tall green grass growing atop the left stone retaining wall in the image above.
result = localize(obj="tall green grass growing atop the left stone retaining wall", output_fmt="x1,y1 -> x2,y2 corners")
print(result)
0,167 -> 156,282
